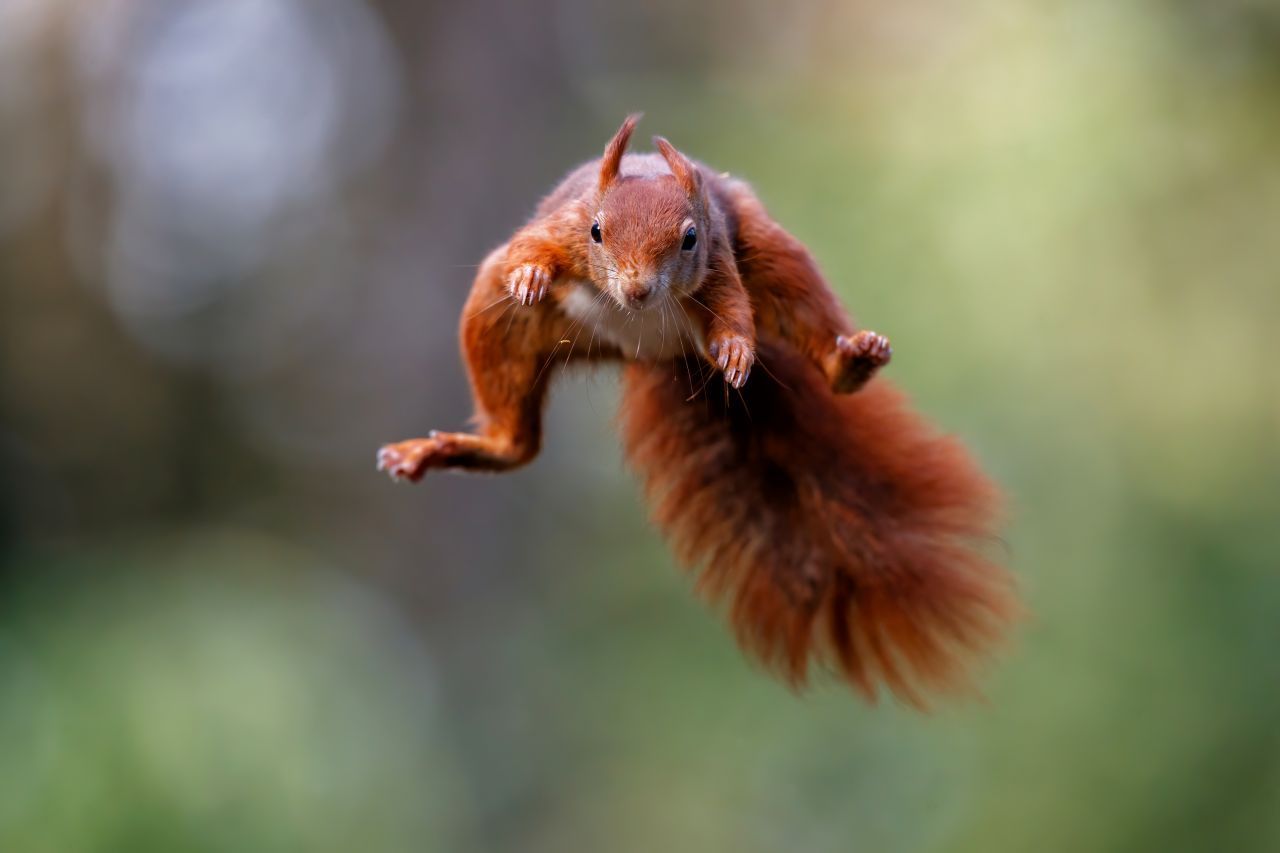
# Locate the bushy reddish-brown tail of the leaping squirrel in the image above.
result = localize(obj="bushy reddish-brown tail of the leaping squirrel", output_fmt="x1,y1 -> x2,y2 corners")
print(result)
621,341 -> 1018,707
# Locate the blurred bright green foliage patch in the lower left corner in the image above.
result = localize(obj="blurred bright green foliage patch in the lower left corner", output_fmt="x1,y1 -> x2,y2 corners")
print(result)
0,534 -> 462,852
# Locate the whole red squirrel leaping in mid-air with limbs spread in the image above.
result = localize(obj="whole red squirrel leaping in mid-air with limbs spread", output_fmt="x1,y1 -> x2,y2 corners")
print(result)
378,115 -> 1018,706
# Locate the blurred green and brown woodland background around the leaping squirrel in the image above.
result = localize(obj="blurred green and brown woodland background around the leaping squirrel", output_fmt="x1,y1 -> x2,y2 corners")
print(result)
0,0 -> 1280,853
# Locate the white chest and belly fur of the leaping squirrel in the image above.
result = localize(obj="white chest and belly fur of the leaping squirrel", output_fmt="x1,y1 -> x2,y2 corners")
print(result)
561,283 -> 703,361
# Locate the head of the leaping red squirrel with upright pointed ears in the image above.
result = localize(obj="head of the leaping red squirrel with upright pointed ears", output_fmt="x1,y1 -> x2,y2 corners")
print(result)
584,115 -> 710,310
